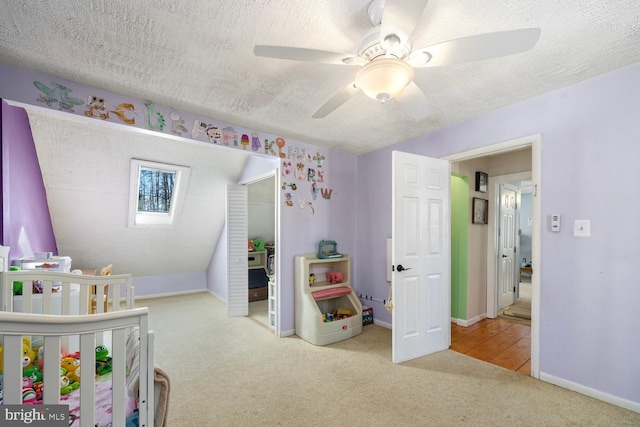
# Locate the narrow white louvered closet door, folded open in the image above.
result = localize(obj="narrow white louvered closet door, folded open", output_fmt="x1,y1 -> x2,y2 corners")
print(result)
226,185 -> 249,316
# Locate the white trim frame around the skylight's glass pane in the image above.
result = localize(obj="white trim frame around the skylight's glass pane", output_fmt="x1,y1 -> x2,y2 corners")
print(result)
129,159 -> 191,228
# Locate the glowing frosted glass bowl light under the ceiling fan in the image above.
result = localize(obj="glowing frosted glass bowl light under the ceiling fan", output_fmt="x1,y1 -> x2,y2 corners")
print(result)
356,58 -> 414,103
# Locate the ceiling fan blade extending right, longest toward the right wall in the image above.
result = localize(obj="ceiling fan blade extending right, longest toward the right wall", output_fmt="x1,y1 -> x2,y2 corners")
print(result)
408,28 -> 541,67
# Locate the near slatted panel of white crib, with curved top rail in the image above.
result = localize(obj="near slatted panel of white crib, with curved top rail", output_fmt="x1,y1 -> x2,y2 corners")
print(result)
0,308 -> 155,427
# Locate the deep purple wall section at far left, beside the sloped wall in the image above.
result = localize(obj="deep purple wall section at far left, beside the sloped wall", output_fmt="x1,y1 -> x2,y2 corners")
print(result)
2,101 -> 58,259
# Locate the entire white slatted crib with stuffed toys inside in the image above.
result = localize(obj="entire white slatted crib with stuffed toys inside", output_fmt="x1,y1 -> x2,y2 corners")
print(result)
0,251 -> 169,427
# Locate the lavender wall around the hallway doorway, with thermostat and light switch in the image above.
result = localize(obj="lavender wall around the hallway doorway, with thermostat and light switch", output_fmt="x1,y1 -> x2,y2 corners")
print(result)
357,64 -> 640,410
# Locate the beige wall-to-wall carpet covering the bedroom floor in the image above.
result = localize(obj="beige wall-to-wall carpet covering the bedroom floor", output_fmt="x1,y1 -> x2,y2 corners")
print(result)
137,293 -> 640,427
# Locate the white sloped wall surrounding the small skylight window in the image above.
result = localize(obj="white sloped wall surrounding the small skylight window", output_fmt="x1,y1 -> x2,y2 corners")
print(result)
28,110 -> 247,276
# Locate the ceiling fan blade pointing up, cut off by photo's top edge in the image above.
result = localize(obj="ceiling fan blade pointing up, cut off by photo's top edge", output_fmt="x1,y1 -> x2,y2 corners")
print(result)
380,0 -> 427,46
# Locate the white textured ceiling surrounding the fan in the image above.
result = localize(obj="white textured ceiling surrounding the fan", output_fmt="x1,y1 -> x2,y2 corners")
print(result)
0,0 -> 640,153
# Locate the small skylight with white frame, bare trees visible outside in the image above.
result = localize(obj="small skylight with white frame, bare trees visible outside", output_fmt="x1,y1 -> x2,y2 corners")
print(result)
129,159 -> 189,227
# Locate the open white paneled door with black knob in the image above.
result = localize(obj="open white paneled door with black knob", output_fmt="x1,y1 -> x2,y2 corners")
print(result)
391,151 -> 451,363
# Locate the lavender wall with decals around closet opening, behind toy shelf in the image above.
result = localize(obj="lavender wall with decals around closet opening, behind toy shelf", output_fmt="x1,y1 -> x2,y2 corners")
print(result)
206,142 -> 359,335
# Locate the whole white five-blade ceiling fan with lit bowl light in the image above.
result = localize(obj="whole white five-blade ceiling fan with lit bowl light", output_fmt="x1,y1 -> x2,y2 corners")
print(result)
253,0 -> 540,120
